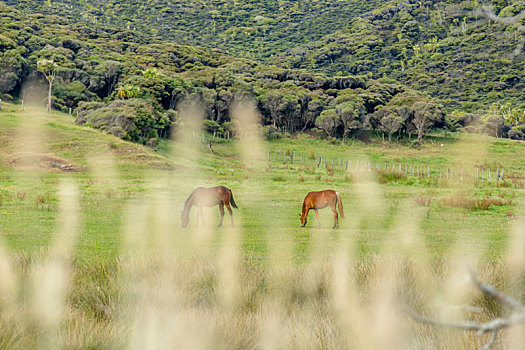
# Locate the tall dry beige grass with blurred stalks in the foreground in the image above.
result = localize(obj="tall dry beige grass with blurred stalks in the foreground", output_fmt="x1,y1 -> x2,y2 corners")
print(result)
0,100 -> 525,349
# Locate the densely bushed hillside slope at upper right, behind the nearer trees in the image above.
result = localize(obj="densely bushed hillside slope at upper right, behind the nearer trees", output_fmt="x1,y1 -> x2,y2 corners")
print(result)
277,1 -> 525,112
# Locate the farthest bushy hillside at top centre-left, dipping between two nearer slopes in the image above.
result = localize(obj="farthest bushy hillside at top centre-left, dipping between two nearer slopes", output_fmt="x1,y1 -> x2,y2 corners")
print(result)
6,0 -> 385,59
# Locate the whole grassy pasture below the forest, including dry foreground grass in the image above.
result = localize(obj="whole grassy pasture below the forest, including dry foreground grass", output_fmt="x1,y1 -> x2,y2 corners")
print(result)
0,103 -> 525,348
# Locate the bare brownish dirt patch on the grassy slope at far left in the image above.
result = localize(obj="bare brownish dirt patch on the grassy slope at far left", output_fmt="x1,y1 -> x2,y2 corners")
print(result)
5,152 -> 85,172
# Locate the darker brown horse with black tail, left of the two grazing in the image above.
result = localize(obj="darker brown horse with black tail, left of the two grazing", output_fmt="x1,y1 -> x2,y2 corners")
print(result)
180,186 -> 239,227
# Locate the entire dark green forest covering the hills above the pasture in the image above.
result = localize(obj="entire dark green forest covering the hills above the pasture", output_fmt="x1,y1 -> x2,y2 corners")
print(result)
0,0 -> 525,145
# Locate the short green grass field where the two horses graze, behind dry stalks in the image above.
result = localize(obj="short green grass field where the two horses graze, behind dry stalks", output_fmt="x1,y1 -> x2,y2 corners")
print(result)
0,100 -> 525,260
